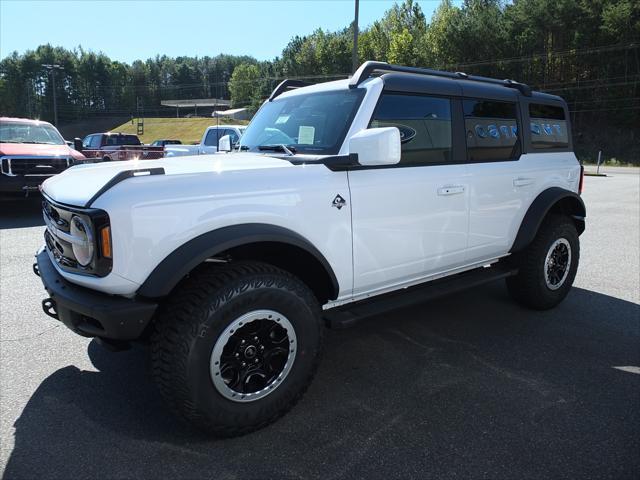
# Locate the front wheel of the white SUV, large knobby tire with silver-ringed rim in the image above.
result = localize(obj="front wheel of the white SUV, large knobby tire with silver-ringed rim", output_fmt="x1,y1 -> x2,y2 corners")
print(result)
151,262 -> 323,437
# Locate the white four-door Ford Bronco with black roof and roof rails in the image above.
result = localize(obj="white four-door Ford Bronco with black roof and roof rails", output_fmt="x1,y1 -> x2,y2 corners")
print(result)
34,62 -> 585,436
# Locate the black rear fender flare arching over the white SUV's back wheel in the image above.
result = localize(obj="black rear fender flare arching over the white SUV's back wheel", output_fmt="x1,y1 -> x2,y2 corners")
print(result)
509,187 -> 587,253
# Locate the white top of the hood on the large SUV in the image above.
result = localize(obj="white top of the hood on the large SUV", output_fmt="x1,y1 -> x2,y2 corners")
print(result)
42,153 -> 291,207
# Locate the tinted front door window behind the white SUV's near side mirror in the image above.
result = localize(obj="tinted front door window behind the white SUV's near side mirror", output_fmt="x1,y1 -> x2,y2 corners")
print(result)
370,93 -> 451,165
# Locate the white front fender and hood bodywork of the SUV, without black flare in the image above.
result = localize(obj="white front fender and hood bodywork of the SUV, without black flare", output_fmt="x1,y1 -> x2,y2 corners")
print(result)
44,153 -> 352,296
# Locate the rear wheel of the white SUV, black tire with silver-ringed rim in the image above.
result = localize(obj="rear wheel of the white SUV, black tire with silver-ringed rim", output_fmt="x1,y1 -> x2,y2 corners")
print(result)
507,215 -> 580,310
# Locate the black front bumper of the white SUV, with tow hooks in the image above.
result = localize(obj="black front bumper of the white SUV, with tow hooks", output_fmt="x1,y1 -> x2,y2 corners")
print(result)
33,249 -> 158,341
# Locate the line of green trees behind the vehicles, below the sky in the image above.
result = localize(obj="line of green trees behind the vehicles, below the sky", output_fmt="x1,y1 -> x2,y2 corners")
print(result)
0,0 -> 640,162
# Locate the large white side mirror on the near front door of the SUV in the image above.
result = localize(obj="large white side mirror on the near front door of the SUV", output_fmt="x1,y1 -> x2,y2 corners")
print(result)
349,127 -> 400,166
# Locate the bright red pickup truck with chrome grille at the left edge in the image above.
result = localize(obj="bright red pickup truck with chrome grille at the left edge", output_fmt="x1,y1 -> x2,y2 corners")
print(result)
0,117 -> 87,196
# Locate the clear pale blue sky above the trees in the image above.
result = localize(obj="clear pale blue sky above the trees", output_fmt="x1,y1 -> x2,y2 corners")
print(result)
0,0 -> 439,62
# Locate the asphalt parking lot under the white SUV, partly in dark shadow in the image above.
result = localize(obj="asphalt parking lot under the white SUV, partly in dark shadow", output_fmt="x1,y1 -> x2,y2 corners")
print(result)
0,169 -> 640,479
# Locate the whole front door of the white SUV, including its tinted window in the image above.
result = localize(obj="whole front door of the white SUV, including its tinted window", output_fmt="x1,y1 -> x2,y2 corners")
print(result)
349,92 -> 469,295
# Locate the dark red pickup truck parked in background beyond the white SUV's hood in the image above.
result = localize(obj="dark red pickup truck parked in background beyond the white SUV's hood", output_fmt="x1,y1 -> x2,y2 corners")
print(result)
82,132 -> 164,162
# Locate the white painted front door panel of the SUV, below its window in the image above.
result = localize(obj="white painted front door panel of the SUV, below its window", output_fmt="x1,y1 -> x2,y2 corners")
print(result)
349,165 -> 469,294
